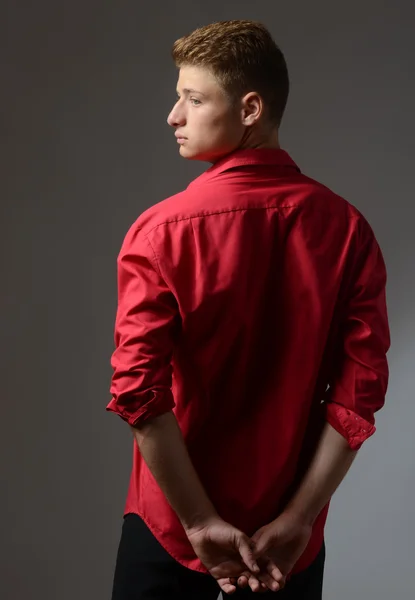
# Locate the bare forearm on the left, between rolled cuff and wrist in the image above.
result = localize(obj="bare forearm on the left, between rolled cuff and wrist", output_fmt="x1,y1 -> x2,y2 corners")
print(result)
132,412 -> 217,530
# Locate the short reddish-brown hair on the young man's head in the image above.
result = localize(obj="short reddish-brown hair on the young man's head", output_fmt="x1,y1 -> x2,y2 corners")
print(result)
172,20 -> 290,126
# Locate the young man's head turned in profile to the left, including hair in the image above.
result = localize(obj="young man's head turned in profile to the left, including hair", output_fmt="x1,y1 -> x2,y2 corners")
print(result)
167,21 -> 289,163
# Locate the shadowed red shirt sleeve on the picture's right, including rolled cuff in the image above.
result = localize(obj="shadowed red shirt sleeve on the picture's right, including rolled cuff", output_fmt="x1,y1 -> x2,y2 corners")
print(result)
326,222 -> 390,450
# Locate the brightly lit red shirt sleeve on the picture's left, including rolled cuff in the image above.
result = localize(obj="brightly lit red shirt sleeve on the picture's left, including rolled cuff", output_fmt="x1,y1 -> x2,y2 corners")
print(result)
107,227 -> 179,426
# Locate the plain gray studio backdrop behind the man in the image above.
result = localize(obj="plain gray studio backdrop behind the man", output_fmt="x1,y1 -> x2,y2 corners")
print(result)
0,0 -> 415,600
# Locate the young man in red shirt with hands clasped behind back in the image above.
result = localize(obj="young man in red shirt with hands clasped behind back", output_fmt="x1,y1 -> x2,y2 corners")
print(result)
108,21 -> 389,600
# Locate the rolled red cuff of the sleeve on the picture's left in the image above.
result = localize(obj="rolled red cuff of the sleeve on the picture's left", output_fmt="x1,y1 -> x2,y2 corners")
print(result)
106,390 -> 175,427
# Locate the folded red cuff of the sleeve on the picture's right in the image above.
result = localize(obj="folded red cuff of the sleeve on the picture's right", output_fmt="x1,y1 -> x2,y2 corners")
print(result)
326,402 -> 376,450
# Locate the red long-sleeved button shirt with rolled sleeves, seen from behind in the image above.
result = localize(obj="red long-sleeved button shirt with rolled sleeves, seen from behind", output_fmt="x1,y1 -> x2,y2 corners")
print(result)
107,149 -> 389,572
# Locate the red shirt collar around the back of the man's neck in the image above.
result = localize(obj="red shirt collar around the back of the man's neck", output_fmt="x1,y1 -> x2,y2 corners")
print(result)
190,148 -> 301,185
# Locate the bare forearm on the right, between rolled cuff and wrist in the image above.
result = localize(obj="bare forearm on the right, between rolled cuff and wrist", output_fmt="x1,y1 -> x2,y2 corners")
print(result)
284,423 -> 357,524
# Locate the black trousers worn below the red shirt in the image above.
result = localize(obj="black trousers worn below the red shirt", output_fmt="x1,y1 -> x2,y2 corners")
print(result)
112,514 -> 325,600
